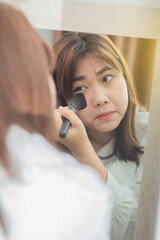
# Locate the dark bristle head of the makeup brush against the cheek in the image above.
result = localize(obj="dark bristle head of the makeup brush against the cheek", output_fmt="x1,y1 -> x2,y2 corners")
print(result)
68,93 -> 87,110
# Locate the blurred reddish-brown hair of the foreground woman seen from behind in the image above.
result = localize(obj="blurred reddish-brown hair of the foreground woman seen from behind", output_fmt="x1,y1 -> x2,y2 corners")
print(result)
0,3 -> 53,173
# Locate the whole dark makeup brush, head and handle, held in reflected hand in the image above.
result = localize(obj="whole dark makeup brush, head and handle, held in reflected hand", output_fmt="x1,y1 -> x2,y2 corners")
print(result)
59,93 -> 87,138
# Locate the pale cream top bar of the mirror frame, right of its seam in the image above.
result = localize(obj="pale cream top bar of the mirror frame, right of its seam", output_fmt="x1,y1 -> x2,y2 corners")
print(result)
61,1 -> 160,39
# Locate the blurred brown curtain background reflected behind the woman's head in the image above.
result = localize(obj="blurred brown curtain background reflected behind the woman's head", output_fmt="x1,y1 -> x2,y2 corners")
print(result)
37,29 -> 156,110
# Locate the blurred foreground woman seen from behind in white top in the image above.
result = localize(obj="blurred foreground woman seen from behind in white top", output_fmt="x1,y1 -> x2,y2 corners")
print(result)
0,3 -> 111,240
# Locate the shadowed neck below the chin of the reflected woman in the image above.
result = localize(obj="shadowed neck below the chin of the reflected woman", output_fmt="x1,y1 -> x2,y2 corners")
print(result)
86,129 -> 116,152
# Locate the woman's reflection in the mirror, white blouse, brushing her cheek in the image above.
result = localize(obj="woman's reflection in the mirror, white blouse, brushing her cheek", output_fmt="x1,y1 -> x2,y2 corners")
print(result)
53,33 -> 148,240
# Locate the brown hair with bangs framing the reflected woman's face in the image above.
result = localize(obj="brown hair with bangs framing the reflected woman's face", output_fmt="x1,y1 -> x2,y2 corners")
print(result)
53,33 -> 143,164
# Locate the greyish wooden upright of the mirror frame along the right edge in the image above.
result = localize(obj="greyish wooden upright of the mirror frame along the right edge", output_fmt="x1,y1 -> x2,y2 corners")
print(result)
134,40 -> 160,240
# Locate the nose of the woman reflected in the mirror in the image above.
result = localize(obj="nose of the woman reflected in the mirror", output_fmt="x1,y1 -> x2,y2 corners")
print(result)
93,86 -> 109,107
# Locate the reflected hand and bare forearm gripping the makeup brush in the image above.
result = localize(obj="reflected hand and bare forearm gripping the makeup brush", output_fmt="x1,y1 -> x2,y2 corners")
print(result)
54,107 -> 107,180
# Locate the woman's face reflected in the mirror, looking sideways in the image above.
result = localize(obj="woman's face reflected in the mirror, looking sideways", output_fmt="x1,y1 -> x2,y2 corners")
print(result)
73,56 -> 128,136
